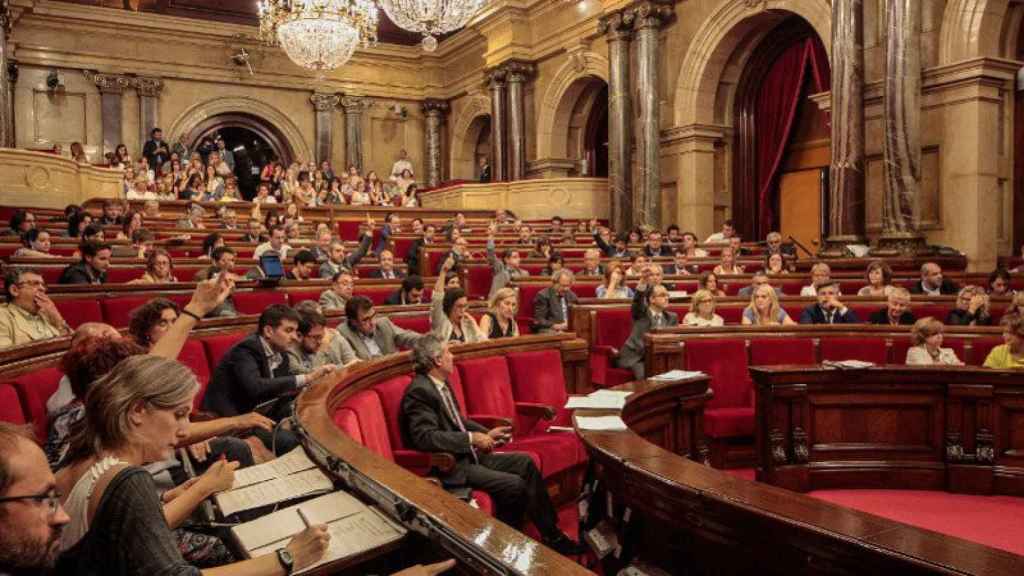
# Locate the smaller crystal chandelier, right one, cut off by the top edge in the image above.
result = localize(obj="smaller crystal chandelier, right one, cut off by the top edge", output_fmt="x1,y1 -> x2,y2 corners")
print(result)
380,0 -> 487,52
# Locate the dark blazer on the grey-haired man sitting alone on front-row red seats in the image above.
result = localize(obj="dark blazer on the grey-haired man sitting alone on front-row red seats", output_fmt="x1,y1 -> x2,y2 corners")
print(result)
398,374 -> 487,486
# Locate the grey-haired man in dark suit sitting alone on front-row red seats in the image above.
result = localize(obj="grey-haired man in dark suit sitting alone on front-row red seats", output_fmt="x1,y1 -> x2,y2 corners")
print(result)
399,334 -> 583,556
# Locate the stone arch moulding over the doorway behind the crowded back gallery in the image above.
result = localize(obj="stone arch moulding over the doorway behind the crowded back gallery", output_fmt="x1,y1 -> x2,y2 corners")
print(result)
168,96 -> 313,161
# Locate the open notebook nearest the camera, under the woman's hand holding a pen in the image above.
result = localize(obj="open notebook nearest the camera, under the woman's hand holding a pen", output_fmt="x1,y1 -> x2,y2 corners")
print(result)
231,491 -> 407,574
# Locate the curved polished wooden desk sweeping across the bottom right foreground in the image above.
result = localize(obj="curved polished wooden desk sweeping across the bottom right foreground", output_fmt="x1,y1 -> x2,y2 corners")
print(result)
580,368 -> 1024,576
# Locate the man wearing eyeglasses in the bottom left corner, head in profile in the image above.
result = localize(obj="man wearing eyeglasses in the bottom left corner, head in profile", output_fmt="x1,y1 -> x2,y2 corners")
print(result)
0,422 -> 71,575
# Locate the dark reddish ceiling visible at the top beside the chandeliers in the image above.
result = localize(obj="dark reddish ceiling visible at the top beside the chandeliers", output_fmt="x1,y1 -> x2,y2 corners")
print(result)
56,0 -> 438,46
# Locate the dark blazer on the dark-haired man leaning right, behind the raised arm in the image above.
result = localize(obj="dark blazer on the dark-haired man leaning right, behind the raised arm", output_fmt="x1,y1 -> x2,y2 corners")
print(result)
203,334 -> 296,416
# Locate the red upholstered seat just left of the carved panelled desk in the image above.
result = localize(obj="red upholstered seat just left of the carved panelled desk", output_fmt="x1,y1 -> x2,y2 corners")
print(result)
683,339 -> 754,438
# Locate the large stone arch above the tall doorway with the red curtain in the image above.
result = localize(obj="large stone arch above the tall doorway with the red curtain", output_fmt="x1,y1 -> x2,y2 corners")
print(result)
673,0 -> 831,126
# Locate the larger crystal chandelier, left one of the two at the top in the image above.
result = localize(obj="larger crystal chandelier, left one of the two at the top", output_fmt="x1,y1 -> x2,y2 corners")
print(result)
259,0 -> 378,72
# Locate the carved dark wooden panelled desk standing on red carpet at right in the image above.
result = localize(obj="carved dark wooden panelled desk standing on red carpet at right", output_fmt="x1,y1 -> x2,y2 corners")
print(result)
751,366 -> 1024,496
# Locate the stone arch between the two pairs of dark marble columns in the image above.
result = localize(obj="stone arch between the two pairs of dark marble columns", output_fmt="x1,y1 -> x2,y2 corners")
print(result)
537,51 -> 608,159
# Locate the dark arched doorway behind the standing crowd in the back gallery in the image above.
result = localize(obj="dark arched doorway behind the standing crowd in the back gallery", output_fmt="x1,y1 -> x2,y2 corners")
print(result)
185,113 -> 295,199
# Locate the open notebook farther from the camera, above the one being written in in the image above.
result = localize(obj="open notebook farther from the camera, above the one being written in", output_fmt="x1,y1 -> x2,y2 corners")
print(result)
213,447 -> 334,517
